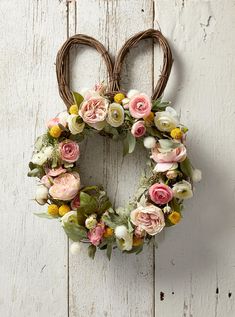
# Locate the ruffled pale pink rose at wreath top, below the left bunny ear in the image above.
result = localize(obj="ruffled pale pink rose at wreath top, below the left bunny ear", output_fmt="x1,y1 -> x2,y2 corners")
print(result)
79,97 -> 108,124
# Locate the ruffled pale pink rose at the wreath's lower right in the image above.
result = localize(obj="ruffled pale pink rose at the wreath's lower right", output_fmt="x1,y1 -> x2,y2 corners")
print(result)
130,204 -> 165,236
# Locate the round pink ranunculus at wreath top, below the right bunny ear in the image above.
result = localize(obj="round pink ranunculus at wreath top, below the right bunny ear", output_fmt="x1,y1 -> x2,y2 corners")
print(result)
129,94 -> 152,119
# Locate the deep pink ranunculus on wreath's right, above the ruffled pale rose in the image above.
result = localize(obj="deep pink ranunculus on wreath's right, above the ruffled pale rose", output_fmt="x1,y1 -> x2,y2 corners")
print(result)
149,183 -> 174,205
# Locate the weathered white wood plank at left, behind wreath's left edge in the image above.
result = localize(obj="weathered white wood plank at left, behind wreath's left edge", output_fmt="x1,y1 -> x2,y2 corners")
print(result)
0,0 -> 67,317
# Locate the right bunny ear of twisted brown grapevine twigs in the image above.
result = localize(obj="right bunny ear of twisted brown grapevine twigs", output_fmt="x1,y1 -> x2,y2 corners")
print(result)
112,29 -> 173,100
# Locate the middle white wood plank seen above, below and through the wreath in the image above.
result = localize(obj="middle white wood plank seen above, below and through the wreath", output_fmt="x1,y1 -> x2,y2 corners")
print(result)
70,0 -> 153,317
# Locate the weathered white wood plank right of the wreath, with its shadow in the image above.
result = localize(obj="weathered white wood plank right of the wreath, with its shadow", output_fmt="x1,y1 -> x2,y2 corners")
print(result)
155,0 -> 235,317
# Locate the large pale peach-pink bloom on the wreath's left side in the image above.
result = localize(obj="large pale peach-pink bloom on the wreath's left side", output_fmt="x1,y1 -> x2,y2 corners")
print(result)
49,172 -> 80,200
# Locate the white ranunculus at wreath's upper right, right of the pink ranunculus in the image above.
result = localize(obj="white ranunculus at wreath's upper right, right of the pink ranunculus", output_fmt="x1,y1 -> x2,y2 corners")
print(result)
154,107 -> 179,132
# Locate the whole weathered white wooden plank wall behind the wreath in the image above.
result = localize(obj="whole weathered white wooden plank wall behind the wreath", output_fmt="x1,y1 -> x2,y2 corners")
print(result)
0,0 -> 235,317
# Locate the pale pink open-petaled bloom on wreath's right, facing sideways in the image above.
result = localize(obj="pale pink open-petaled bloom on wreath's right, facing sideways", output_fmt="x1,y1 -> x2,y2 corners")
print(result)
150,143 -> 187,172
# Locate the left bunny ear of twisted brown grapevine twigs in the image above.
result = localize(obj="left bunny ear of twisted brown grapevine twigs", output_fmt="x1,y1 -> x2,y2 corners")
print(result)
56,34 -> 113,108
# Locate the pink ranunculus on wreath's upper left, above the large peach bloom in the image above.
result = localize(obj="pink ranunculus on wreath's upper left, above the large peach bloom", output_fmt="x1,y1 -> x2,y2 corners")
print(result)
59,140 -> 80,163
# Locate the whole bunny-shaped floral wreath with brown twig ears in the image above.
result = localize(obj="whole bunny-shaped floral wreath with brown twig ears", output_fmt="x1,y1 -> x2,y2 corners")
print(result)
28,29 -> 201,259
